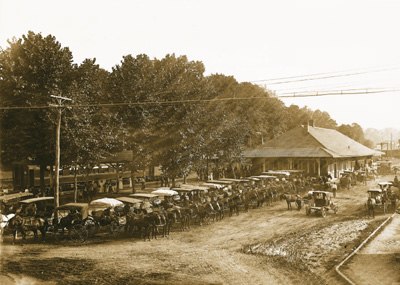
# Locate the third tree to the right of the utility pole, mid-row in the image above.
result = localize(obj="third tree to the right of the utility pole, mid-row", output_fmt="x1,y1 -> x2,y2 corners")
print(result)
151,55 -> 207,183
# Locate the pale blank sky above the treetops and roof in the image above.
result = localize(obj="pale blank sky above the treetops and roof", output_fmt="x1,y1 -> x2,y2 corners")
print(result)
0,0 -> 400,129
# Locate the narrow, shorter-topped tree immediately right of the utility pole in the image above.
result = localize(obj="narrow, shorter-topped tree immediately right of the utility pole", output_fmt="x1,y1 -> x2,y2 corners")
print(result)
61,59 -> 122,199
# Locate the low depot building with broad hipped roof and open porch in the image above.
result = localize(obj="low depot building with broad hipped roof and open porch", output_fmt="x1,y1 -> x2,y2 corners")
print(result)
243,124 -> 381,178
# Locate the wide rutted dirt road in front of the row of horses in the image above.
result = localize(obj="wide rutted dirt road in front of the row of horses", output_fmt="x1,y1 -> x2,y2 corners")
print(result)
0,179 -> 394,284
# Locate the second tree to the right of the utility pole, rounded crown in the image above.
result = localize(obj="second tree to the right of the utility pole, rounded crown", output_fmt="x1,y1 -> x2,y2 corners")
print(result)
107,54 -> 158,190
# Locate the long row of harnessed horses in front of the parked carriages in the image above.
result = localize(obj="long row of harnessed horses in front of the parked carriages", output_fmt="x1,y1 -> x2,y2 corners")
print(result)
1,181 -> 301,241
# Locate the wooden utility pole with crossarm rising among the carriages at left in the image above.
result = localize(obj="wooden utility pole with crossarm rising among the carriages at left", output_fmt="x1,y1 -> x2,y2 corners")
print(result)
50,95 -> 72,213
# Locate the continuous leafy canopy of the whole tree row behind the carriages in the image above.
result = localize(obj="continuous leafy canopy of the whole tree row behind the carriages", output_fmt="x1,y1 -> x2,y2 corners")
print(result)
0,32 -> 376,182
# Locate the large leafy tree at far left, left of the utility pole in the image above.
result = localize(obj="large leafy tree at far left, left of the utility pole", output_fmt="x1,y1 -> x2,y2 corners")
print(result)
0,32 -> 73,191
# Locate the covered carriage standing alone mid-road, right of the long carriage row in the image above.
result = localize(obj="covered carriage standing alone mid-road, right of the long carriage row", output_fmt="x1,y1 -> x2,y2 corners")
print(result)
305,191 -> 338,218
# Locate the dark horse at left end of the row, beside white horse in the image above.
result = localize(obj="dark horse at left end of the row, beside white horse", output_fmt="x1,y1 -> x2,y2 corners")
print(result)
8,214 -> 48,243
